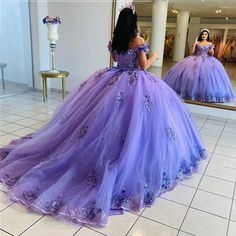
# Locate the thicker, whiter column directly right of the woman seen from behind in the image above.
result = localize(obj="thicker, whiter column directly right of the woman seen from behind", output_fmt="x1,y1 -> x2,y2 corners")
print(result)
151,0 -> 168,67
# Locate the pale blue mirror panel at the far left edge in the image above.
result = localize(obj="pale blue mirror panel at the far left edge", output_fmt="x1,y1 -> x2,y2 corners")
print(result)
0,1 -> 33,98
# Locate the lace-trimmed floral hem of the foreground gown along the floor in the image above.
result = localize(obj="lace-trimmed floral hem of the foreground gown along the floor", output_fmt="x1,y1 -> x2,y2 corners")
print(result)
0,149 -> 207,227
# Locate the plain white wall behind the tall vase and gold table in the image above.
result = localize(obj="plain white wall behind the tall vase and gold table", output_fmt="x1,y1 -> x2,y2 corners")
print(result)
31,0 -> 112,91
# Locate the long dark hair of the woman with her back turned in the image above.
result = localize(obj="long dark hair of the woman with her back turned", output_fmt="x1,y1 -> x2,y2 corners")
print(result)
112,8 -> 138,53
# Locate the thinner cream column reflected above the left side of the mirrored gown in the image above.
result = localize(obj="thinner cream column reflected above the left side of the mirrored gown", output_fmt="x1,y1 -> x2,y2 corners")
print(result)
173,11 -> 189,61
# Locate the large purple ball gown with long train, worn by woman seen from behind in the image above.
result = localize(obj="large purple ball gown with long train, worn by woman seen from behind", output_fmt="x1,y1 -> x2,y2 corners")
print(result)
0,45 -> 206,226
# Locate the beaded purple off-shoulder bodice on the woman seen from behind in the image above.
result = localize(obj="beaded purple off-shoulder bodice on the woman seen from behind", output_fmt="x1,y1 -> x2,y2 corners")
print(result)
108,43 -> 149,70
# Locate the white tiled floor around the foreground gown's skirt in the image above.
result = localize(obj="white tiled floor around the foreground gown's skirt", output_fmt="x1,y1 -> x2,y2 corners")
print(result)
0,92 -> 236,236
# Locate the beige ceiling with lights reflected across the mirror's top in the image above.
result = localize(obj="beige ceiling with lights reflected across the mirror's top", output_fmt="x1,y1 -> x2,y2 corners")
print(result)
134,0 -> 236,18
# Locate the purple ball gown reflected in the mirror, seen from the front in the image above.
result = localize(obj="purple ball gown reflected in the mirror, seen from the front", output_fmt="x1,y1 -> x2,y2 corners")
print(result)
164,44 -> 235,102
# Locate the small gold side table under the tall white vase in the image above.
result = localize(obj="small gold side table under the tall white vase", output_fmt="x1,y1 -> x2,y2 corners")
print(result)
39,70 -> 69,102
